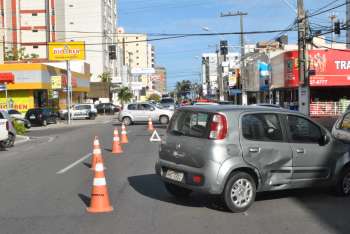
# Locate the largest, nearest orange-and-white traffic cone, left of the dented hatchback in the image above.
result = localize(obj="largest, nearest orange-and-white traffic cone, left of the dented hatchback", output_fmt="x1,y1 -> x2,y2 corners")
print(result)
86,159 -> 113,213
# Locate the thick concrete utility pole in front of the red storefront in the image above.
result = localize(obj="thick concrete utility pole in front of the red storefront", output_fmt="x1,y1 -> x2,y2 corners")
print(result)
298,0 -> 310,115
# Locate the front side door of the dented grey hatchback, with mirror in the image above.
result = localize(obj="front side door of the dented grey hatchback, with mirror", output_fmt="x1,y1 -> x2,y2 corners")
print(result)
286,115 -> 337,183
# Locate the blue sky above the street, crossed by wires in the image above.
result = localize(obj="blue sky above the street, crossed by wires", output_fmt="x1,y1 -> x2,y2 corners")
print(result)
117,0 -> 345,91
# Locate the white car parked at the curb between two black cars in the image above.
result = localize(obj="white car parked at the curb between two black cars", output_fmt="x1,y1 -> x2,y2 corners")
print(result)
60,104 -> 97,119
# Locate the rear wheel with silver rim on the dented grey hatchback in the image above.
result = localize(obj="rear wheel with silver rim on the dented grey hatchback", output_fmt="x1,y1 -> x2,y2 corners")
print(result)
223,171 -> 256,213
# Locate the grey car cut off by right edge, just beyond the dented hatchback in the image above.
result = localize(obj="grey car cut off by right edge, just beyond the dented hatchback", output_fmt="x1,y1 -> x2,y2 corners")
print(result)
332,111 -> 350,144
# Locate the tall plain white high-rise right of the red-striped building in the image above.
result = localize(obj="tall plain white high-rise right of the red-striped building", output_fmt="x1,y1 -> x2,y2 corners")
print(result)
55,0 -> 120,83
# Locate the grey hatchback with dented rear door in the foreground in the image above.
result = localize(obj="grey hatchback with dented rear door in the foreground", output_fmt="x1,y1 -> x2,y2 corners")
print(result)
155,105 -> 350,212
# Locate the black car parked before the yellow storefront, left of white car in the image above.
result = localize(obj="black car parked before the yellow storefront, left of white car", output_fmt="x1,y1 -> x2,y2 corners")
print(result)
25,108 -> 58,126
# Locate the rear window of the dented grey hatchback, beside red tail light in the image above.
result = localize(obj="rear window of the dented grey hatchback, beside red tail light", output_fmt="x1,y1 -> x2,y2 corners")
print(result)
168,111 -> 210,138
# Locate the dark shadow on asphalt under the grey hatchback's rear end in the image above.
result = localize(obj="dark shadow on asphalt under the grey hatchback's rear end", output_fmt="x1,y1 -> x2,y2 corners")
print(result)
128,174 -> 228,212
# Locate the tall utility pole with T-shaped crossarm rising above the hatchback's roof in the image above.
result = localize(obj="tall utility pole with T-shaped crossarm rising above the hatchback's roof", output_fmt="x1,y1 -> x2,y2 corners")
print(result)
221,11 -> 248,105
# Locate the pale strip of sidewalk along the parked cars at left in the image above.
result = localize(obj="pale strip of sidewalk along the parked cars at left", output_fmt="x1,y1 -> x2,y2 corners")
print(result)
28,115 -> 118,132
